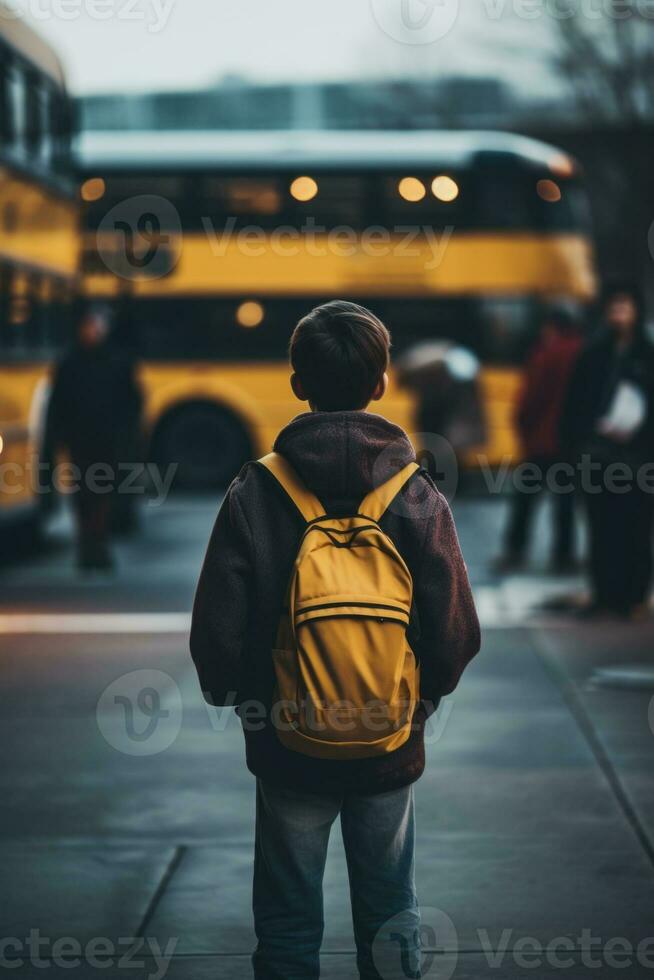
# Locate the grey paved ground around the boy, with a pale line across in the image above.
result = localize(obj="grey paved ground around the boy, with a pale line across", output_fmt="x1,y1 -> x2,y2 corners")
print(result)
0,497 -> 654,980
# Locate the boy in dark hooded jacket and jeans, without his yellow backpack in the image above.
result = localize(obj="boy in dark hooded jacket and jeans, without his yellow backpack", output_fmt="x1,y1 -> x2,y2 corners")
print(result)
191,301 -> 480,980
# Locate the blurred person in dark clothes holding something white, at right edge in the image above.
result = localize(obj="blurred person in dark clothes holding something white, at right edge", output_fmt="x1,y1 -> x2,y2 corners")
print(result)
561,285 -> 654,617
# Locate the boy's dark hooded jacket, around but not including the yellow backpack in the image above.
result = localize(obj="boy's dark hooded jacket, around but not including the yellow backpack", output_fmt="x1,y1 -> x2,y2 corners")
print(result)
191,412 -> 480,793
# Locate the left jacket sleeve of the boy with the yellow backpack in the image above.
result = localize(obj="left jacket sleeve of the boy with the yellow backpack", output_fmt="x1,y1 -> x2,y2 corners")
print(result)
191,479 -> 252,705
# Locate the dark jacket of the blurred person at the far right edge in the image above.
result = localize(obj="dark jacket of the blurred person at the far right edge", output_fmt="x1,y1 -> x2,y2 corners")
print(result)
560,331 -> 654,464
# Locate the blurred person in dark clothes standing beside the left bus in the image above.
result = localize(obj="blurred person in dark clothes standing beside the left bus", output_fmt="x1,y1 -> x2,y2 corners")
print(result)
48,308 -> 141,570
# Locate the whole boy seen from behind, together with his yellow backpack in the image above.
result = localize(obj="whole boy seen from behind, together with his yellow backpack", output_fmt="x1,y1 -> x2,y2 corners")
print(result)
191,302 -> 480,980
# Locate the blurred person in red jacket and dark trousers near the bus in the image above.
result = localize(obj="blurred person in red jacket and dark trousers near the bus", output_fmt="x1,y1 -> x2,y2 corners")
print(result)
499,309 -> 582,571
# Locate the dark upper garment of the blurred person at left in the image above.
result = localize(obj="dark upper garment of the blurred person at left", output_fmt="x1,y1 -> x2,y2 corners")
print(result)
48,344 -> 141,463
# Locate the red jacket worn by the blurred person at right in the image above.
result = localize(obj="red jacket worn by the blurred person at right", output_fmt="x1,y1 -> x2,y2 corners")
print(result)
516,333 -> 581,458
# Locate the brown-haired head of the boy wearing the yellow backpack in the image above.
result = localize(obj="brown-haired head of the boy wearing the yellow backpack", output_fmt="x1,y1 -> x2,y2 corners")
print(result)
289,300 -> 391,412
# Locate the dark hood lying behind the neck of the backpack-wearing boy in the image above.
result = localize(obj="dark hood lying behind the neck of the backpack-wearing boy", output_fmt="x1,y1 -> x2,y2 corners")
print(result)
274,412 -> 416,502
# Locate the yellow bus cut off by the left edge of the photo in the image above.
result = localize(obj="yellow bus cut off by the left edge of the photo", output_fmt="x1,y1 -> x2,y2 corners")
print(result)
0,3 -> 79,531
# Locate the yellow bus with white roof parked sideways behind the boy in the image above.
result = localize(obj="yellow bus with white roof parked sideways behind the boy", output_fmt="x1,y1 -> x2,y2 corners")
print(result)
78,131 -> 595,485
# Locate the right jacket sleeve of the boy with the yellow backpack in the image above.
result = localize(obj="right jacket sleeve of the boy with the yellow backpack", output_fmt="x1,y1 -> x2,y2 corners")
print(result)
414,491 -> 481,702
